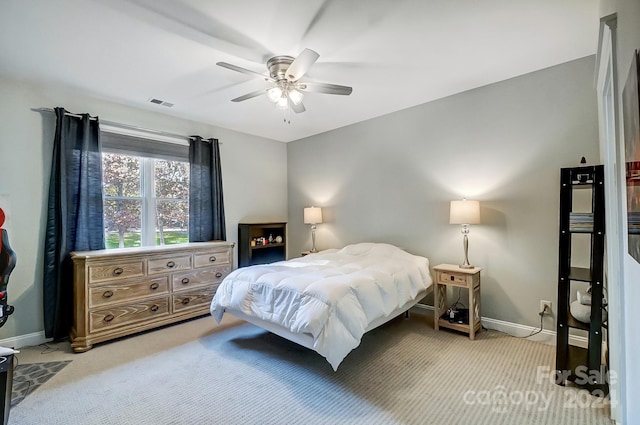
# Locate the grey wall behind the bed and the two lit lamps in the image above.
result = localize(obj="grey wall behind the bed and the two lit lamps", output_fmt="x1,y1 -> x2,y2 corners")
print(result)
287,57 -> 599,330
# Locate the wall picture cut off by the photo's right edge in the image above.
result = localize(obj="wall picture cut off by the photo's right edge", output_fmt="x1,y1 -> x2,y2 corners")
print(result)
622,50 -> 640,263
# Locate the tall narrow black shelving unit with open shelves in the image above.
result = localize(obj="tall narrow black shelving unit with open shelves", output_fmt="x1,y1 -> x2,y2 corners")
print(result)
556,165 -> 608,395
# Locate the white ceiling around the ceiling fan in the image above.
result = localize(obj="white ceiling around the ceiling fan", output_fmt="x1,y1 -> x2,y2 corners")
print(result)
0,0 -> 599,142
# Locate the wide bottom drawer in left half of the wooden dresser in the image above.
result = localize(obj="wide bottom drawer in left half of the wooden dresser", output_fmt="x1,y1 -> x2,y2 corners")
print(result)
89,297 -> 169,332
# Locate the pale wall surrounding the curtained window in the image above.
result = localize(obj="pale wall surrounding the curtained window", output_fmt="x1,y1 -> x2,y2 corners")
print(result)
0,77 -> 287,345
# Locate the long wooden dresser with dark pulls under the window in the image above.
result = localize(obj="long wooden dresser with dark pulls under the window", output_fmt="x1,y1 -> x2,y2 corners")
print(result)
70,242 -> 235,353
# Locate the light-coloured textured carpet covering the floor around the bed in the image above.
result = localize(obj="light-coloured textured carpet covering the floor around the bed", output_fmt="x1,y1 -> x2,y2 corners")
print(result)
9,314 -> 612,425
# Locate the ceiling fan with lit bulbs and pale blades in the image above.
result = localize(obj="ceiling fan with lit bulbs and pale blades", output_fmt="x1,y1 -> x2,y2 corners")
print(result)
216,49 -> 353,113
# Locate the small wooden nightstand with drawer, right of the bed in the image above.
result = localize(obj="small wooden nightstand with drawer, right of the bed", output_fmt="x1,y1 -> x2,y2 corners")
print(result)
433,264 -> 482,339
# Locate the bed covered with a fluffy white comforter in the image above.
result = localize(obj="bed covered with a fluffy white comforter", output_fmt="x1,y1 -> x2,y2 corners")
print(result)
210,243 -> 432,370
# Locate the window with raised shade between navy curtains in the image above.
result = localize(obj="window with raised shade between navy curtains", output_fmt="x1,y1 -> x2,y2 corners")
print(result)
101,132 -> 189,249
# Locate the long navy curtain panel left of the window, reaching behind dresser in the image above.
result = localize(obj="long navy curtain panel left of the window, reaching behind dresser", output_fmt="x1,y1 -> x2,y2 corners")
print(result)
43,108 -> 104,340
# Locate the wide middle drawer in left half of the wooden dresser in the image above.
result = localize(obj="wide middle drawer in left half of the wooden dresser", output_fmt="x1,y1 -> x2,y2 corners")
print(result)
89,276 -> 169,308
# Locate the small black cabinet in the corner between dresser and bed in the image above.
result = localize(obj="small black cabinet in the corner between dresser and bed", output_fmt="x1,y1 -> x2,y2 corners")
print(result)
238,222 -> 287,267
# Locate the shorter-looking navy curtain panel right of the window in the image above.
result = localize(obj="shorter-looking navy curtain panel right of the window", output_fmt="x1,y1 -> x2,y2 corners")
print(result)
189,136 -> 227,242
